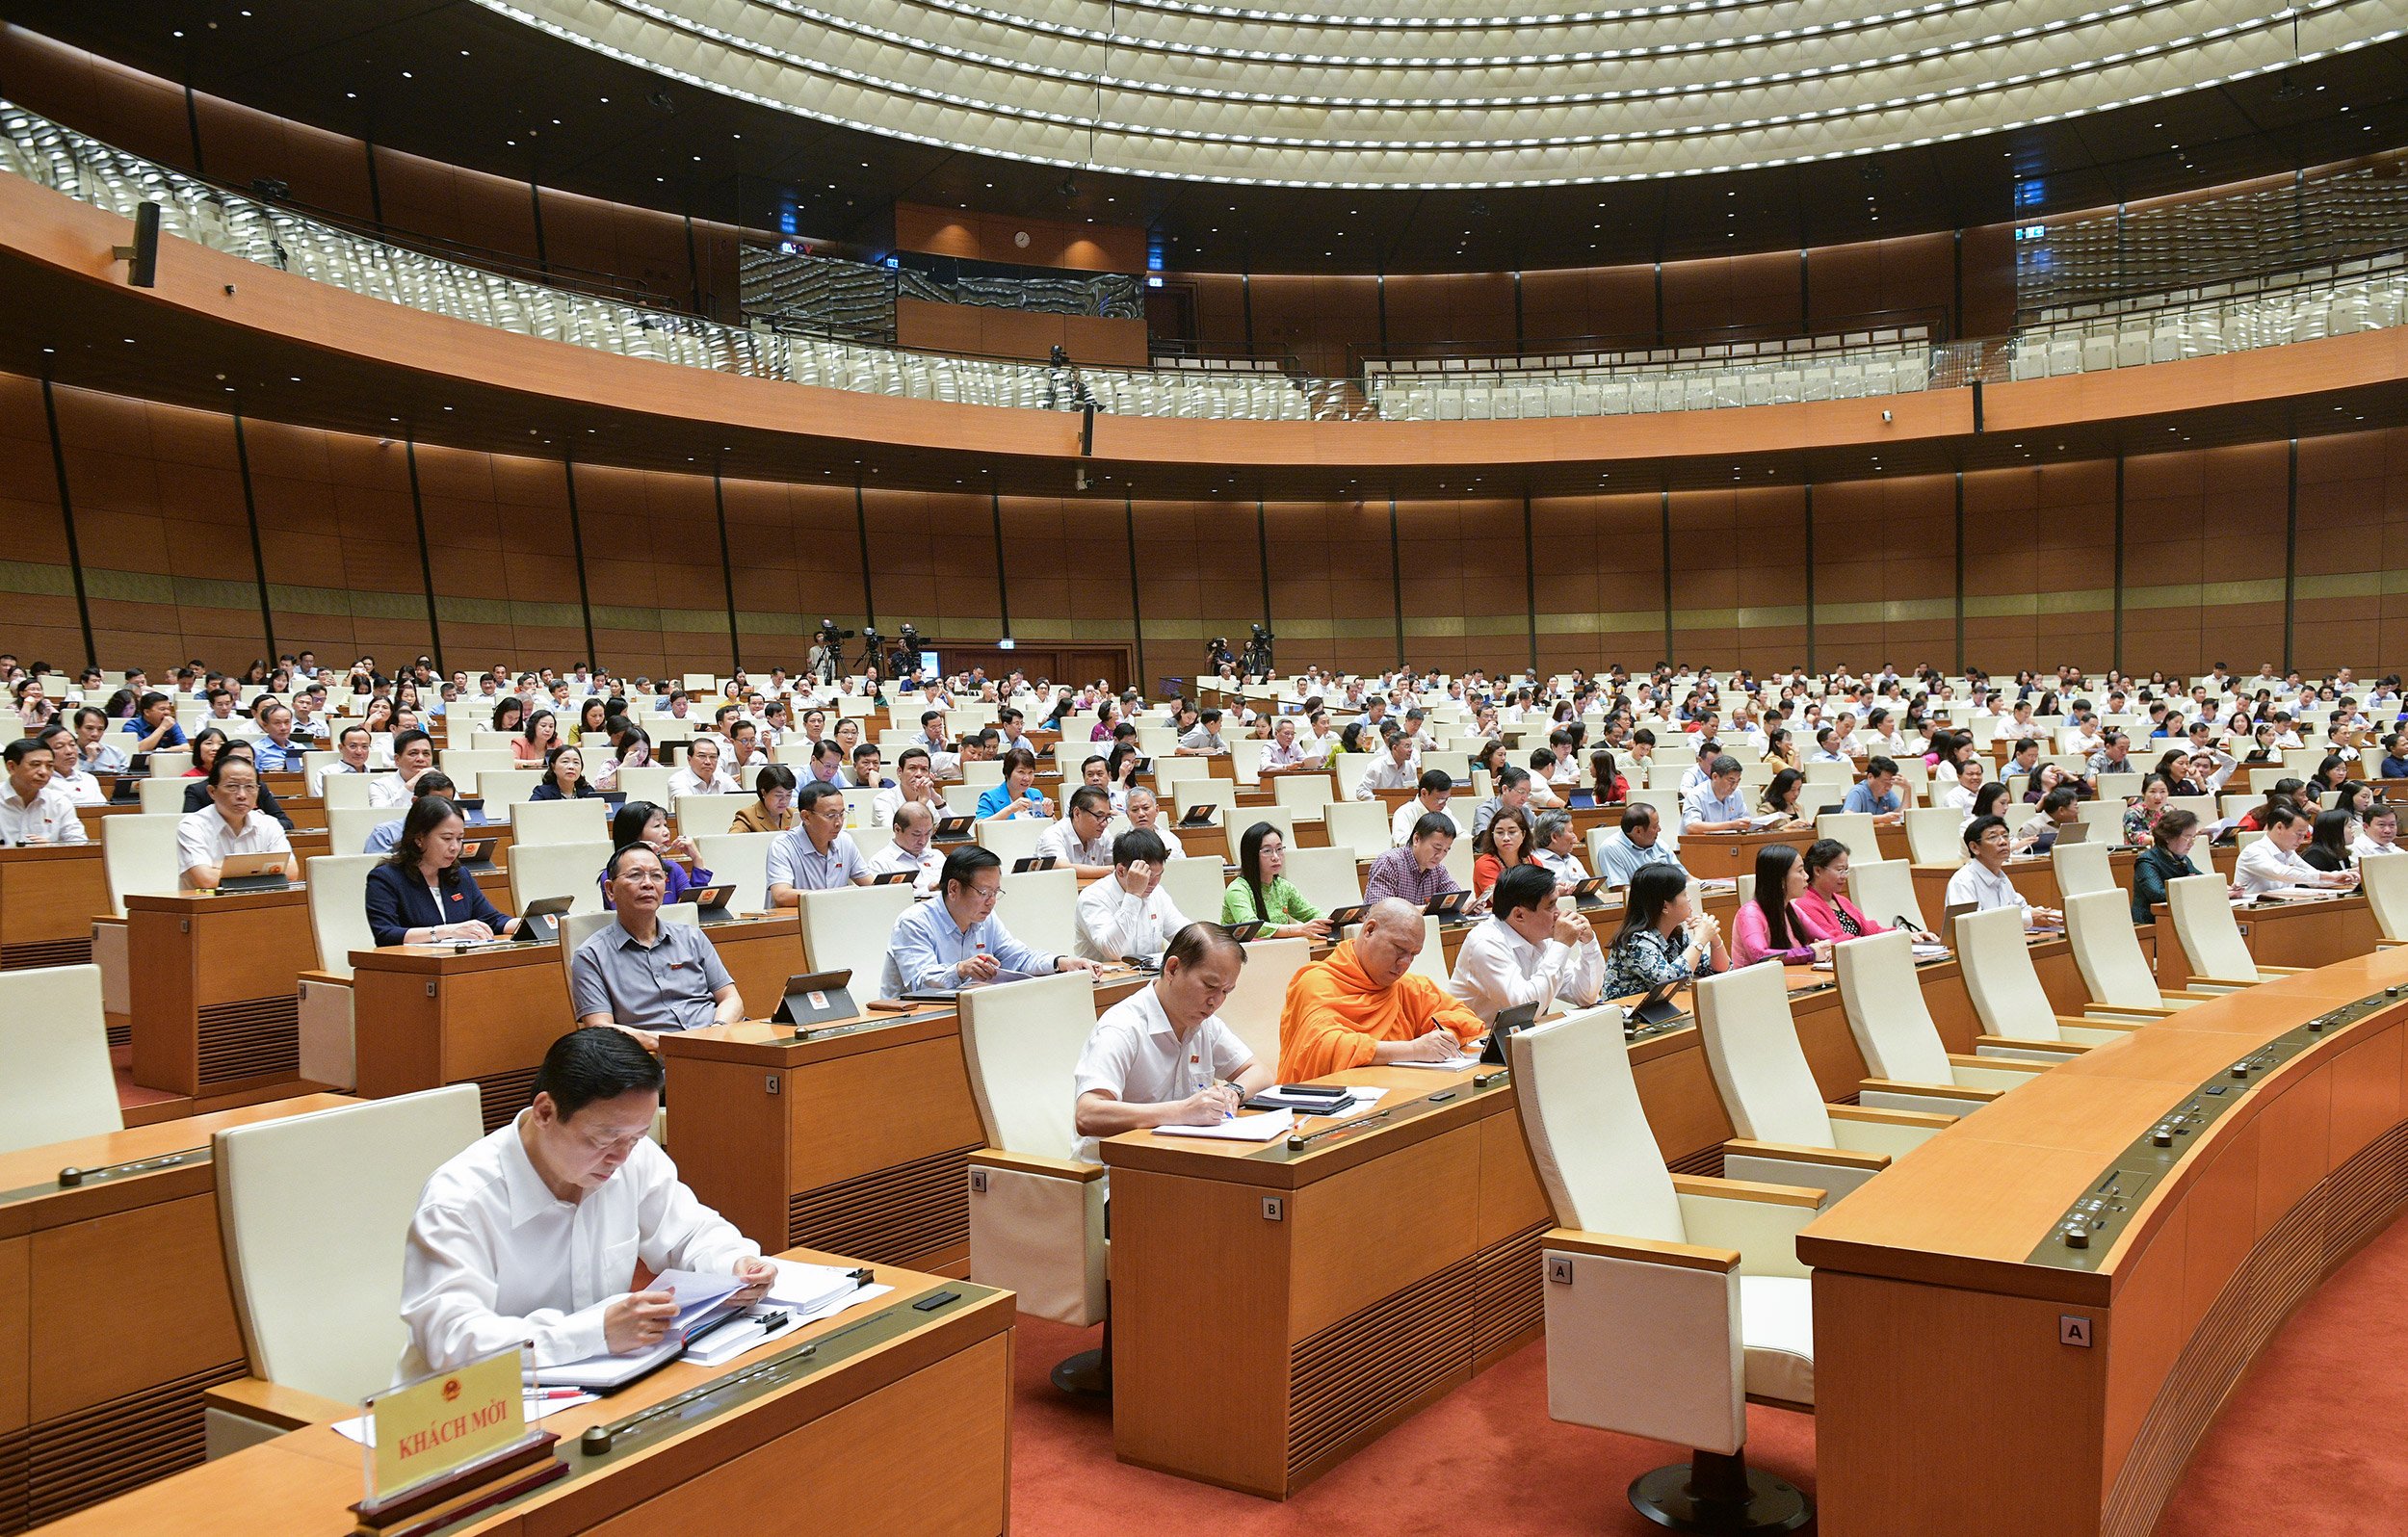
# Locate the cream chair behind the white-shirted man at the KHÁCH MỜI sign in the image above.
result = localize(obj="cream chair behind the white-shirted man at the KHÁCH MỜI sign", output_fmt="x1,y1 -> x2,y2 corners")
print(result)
207,1084 -> 484,1457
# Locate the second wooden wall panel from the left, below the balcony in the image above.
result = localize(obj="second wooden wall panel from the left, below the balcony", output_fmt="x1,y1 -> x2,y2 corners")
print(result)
56,390 -> 268,669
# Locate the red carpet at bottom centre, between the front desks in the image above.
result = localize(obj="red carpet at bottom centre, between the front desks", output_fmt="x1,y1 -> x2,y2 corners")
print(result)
1011,1317 -> 1814,1537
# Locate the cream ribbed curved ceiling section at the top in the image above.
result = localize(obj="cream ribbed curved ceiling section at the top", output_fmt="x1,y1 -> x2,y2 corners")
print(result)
475,0 -> 2403,191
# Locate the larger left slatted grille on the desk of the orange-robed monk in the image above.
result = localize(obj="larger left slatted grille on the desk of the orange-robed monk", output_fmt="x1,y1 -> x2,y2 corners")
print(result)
1289,1258 -> 1479,1489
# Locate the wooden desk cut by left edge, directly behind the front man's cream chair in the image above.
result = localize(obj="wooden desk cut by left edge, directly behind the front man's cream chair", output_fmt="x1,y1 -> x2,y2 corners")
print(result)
0,1094 -> 356,1532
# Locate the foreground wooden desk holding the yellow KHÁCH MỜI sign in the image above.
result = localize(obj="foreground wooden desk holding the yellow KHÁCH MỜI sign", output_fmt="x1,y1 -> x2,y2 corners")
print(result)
38,1250 -> 1011,1537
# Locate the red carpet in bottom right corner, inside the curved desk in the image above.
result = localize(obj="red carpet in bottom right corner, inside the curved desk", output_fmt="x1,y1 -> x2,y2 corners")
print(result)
2158,1221 -> 2408,1537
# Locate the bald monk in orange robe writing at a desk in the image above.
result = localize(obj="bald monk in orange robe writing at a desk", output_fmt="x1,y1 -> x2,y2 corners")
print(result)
1279,897 -> 1488,1081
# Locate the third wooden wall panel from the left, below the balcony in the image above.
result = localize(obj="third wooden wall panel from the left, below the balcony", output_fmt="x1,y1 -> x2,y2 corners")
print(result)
244,422 -> 433,669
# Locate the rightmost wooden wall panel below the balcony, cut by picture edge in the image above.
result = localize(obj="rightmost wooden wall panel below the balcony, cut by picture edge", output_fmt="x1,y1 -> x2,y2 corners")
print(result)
2283,429 -> 2408,672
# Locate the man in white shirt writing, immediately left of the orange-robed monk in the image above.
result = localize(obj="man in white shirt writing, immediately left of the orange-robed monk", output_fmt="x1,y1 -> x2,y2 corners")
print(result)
1072,923 -> 1279,1163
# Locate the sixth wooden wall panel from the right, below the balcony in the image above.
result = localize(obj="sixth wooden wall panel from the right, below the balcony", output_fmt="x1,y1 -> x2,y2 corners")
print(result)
1530,491 -> 1664,672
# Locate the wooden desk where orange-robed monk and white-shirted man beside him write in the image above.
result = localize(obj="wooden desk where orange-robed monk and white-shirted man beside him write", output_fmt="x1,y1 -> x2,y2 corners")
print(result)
1103,1067 -> 1549,1498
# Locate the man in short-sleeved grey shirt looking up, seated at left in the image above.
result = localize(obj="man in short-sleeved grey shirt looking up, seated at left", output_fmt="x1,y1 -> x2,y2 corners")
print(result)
568,844 -> 745,1051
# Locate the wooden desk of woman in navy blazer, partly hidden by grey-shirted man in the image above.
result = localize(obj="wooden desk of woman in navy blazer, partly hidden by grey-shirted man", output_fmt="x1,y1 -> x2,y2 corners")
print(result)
352,913 -> 809,1132
